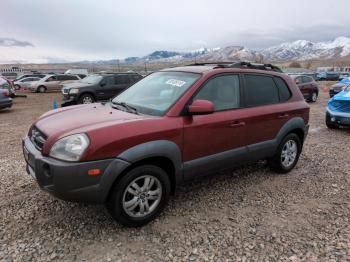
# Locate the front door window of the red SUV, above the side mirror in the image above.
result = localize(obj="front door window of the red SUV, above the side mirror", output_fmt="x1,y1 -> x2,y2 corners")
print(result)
193,75 -> 240,111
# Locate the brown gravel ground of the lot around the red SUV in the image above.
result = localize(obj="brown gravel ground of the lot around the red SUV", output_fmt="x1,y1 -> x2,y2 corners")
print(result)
0,84 -> 350,261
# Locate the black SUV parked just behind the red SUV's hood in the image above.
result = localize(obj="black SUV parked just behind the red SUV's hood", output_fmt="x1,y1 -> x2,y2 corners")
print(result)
62,73 -> 142,107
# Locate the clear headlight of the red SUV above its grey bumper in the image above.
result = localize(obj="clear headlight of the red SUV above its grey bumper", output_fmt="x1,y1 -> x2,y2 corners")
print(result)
50,134 -> 90,161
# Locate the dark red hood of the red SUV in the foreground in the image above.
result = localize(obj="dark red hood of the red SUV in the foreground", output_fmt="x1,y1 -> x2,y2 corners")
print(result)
35,103 -> 147,139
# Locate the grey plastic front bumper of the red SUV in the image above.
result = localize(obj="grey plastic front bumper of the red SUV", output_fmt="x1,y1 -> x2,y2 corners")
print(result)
22,137 -> 130,203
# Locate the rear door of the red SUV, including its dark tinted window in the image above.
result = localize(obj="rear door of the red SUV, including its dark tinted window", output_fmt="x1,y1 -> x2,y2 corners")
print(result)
243,74 -> 292,159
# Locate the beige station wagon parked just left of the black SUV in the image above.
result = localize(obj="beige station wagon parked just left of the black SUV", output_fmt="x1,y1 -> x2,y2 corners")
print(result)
28,74 -> 80,93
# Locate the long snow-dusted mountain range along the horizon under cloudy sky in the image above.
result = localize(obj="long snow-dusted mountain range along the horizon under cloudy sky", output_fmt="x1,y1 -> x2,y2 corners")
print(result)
115,36 -> 350,63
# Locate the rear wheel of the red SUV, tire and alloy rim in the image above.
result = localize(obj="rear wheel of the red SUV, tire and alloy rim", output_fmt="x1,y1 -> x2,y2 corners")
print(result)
269,133 -> 302,174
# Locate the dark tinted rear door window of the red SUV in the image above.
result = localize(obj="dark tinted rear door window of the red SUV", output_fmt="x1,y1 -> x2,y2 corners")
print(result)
244,75 -> 279,106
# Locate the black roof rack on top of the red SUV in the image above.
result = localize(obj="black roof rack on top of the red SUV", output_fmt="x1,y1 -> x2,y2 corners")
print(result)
187,62 -> 283,73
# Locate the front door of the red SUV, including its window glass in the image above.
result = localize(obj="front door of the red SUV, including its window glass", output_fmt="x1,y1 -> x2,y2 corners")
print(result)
183,74 -> 245,179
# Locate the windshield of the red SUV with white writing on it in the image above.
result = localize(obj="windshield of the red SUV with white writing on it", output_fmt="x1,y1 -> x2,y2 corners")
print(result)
112,72 -> 200,116
